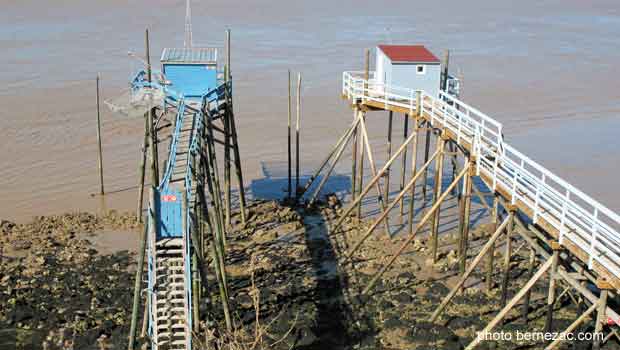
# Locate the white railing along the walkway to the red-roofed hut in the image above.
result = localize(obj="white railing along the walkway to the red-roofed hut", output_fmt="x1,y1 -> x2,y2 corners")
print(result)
342,72 -> 620,278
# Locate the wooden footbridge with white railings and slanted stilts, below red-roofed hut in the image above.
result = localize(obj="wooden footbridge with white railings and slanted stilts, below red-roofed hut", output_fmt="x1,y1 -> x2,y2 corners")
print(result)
305,47 -> 620,349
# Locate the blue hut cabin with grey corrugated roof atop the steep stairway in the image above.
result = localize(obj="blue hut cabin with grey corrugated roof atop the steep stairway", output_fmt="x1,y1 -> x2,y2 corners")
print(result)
161,47 -> 218,99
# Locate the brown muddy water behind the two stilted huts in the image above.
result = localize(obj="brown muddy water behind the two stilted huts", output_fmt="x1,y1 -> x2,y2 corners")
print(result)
0,0 -> 620,220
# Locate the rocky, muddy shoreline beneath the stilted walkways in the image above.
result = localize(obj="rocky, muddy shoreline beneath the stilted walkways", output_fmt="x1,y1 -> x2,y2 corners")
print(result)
0,199 -> 620,349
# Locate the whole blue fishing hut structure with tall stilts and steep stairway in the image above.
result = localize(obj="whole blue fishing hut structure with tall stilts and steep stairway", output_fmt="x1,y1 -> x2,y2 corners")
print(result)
122,28 -> 245,350
